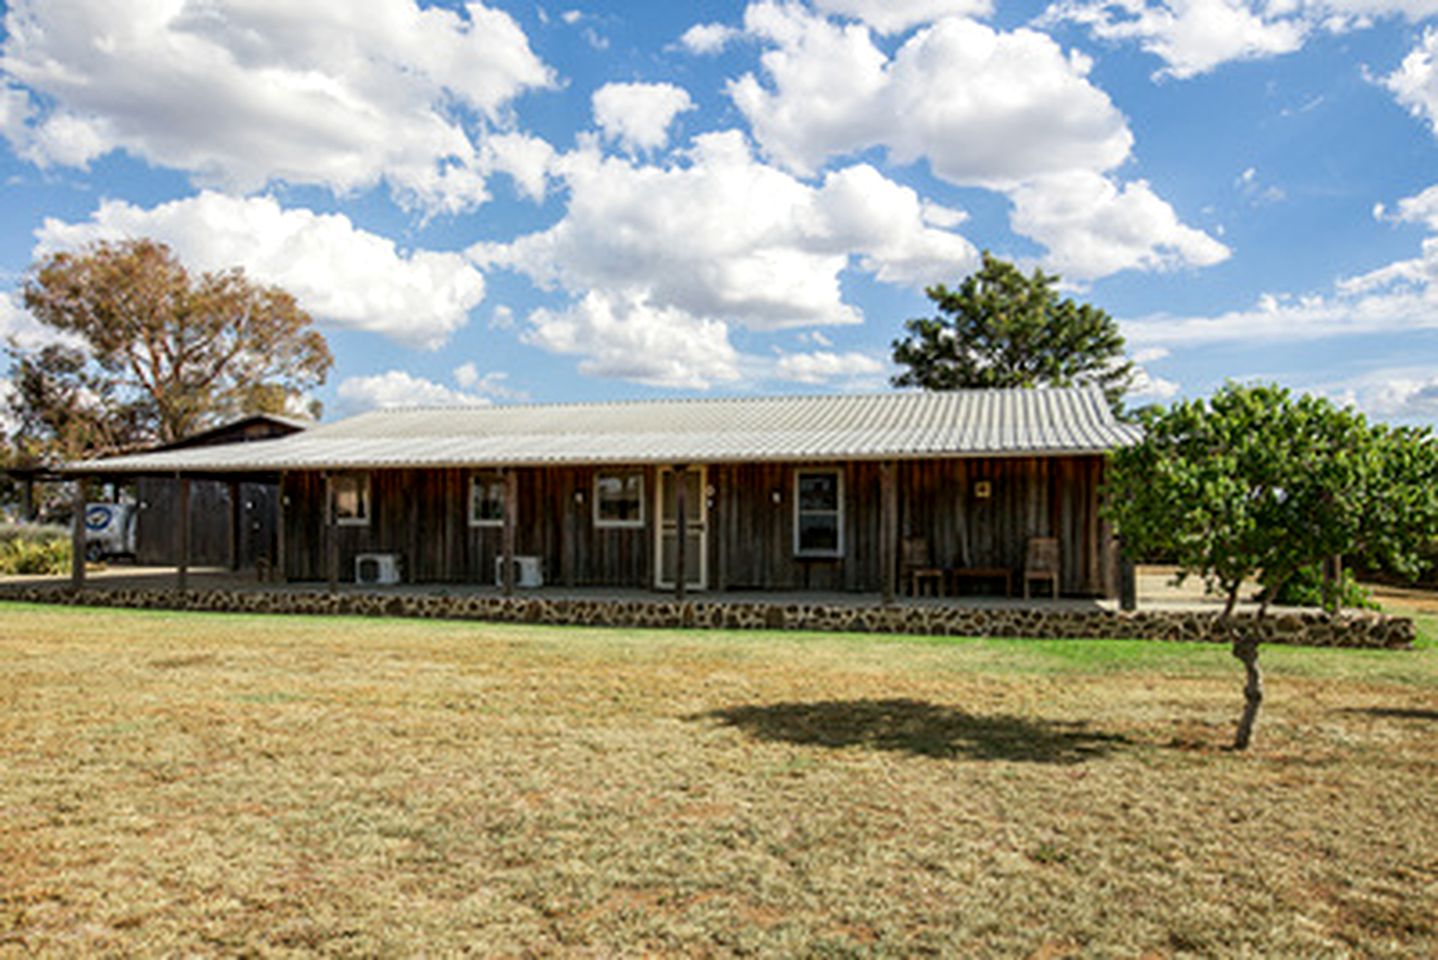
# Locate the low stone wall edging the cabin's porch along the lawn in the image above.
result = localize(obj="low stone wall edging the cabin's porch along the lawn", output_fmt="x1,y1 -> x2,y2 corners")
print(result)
0,583 -> 1414,650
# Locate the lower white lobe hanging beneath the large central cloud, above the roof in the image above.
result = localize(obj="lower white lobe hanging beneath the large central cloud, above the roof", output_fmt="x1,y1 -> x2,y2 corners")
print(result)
525,290 -> 739,389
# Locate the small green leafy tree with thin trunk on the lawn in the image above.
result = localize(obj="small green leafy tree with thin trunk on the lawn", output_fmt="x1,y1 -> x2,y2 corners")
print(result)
1106,384 -> 1438,749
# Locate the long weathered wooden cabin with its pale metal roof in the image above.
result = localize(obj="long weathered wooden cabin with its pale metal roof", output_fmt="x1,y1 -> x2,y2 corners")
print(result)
72,388 -> 1136,596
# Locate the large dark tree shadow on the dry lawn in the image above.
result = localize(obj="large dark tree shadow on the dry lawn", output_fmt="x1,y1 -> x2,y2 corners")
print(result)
690,700 -> 1129,763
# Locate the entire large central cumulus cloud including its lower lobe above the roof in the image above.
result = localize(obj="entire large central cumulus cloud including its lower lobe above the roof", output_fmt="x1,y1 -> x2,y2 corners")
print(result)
469,131 -> 978,385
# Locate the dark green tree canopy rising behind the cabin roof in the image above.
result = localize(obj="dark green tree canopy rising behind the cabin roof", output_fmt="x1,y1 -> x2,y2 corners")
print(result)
893,251 -> 1133,407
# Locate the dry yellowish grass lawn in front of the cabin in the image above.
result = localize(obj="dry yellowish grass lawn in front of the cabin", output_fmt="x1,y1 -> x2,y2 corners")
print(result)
0,604 -> 1438,957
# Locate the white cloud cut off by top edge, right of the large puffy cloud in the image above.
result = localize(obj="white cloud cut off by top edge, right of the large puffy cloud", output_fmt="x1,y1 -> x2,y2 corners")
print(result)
1041,0 -> 1311,79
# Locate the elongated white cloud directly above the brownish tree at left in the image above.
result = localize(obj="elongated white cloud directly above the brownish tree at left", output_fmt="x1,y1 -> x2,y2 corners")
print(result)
35,193 -> 485,348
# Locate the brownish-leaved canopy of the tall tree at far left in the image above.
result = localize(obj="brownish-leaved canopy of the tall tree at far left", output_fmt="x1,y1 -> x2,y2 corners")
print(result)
10,240 -> 334,460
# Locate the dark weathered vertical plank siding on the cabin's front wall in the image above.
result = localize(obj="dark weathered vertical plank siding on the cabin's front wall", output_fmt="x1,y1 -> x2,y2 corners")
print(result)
283,457 -> 1117,596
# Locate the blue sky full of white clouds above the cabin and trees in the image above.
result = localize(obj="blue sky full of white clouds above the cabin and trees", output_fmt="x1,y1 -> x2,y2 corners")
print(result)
0,0 -> 1438,424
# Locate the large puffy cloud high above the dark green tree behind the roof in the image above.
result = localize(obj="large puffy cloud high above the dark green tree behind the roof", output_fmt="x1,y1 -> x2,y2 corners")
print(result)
729,1 -> 1228,279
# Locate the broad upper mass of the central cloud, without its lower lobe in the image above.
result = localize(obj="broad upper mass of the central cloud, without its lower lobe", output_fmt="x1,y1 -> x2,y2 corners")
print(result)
470,131 -> 976,331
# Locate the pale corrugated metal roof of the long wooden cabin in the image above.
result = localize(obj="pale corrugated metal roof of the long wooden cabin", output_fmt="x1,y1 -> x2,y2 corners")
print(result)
68,388 -> 1139,473
